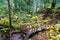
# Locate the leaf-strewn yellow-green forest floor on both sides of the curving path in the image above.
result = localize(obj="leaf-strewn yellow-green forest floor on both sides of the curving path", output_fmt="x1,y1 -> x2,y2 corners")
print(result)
0,13 -> 60,40
